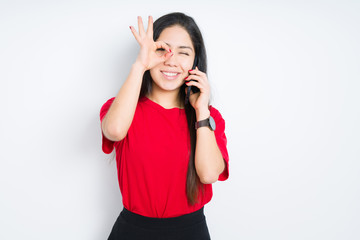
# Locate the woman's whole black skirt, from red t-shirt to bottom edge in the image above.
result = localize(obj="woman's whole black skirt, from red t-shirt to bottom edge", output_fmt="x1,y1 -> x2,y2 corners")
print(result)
108,208 -> 210,240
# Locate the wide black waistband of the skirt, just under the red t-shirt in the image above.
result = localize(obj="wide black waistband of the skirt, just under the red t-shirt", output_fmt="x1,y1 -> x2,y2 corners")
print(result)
120,207 -> 205,228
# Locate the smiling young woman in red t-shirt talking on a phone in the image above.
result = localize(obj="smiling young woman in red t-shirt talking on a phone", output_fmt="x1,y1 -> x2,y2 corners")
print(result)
100,13 -> 229,240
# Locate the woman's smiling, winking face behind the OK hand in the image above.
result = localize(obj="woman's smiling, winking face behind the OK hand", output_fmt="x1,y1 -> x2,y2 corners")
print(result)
150,26 -> 195,91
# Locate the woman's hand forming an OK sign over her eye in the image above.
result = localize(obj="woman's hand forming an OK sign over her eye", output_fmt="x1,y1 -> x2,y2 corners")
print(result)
130,16 -> 173,70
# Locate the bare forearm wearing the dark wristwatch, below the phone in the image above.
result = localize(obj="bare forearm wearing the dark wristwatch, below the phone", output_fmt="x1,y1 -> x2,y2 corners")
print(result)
195,110 -> 225,184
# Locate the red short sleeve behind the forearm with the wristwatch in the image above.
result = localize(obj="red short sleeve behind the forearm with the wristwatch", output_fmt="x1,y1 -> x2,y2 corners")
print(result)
210,106 -> 229,181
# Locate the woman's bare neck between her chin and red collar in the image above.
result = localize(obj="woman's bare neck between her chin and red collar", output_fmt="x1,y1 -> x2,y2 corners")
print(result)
147,84 -> 183,109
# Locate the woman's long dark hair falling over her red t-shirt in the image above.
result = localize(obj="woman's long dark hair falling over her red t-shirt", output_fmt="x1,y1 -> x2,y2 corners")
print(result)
139,12 -> 207,205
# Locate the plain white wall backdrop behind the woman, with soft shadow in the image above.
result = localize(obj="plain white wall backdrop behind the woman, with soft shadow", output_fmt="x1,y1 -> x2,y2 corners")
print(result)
0,0 -> 360,240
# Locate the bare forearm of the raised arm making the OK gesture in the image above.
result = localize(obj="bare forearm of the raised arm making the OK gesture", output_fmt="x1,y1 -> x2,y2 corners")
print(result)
102,62 -> 145,141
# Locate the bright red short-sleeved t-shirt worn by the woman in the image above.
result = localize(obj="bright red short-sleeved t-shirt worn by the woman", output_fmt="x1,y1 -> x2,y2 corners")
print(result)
100,97 -> 229,218
